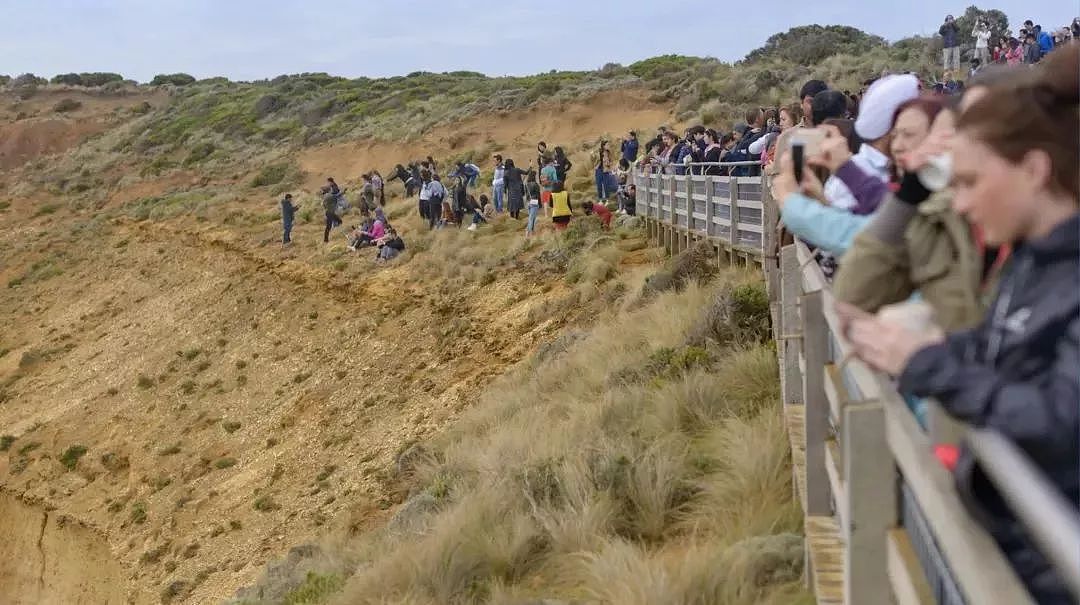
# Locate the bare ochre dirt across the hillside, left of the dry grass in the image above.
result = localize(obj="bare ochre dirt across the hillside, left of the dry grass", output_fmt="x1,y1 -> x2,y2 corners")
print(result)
0,87 -> 665,603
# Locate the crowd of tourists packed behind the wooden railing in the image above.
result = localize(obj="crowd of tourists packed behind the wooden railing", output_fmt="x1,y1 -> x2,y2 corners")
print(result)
652,42 -> 1080,604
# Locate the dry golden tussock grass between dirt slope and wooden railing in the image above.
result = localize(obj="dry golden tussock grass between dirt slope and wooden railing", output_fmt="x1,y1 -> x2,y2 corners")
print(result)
287,269 -> 806,605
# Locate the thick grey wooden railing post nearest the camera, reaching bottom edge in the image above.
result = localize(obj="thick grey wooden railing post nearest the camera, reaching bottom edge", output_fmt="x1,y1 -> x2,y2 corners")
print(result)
837,402 -> 899,605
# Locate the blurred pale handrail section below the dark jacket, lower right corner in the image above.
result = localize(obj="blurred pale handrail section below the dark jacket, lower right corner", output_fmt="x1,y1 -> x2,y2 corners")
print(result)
967,429 -> 1080,600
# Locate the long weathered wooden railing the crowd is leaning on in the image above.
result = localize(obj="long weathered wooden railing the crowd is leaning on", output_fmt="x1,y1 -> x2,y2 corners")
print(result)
636,167 -> 1080,605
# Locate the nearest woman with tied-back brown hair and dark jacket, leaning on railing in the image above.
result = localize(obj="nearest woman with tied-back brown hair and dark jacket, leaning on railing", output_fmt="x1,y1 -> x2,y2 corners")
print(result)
837,45 -> 1080,604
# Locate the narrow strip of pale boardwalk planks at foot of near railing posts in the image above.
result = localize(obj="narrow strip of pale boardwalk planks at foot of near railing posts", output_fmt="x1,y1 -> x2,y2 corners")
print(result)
784,405 -> 843,605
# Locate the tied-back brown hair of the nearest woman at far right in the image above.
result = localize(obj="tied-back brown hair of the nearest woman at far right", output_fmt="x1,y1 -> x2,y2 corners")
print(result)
957,43 -> 1080,200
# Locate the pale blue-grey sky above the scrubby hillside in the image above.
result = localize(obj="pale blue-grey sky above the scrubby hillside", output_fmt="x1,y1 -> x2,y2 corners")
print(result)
0,0 -> 1080,82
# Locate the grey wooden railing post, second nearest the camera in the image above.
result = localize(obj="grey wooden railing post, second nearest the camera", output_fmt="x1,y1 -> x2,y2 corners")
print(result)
801,291 -> 833,516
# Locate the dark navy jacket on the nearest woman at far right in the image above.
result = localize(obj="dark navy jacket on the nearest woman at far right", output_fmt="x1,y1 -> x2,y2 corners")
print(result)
900,215 -> 1080,603
